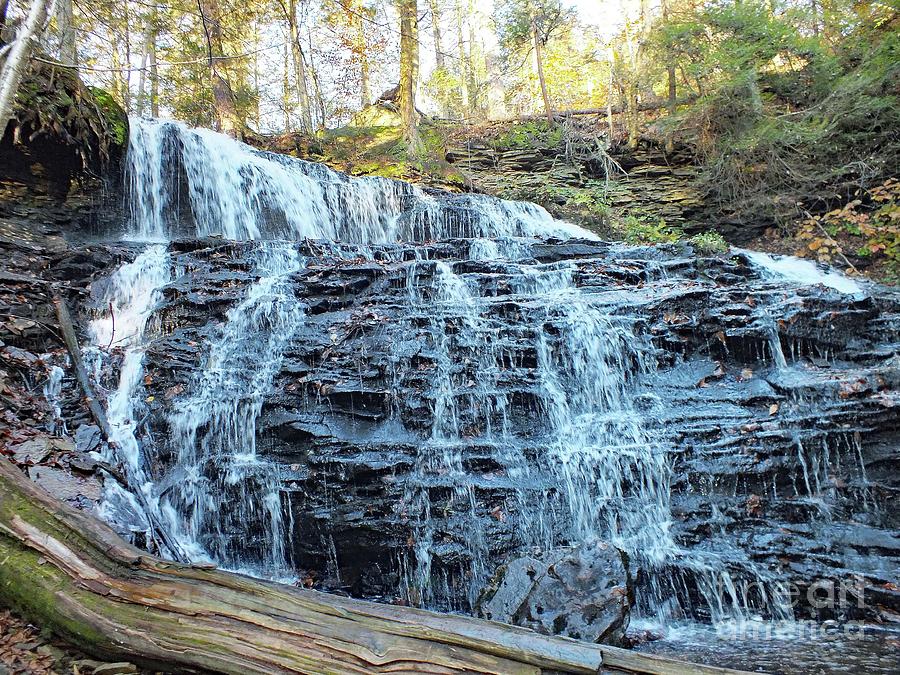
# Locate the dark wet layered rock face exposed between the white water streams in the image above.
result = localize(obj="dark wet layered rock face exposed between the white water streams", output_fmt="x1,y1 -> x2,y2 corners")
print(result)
29,240 -> 900,618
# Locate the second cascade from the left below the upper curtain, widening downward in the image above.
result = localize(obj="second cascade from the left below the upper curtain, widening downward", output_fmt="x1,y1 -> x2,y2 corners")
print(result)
159,242 -> 303,577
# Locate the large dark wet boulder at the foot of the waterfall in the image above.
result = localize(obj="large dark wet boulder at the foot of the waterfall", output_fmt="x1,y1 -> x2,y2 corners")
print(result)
476,541 -> 632,644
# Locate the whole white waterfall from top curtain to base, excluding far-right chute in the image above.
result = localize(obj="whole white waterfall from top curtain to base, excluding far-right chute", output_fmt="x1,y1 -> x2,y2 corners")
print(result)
88,120 -> 876,632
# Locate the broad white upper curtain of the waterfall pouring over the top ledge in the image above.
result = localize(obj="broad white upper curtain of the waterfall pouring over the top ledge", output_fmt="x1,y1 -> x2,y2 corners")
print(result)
126,119 -> 593,244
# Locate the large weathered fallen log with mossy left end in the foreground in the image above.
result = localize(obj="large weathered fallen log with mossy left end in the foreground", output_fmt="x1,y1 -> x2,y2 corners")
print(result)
0,459 -> 760,675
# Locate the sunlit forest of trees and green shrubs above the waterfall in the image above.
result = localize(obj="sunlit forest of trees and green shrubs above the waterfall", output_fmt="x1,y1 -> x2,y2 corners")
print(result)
0,0 -> 900,262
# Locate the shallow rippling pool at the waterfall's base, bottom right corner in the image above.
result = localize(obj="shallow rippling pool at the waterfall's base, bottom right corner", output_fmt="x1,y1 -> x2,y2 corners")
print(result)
629,621 -> 900,675
